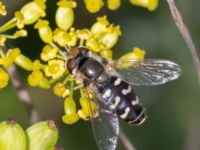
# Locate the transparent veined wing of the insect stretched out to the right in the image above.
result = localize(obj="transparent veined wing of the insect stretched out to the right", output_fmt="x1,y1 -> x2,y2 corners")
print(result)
107,59 -> 181,85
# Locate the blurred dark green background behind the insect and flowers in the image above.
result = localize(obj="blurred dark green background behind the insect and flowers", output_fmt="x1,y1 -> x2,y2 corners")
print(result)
0,0 -> 200,150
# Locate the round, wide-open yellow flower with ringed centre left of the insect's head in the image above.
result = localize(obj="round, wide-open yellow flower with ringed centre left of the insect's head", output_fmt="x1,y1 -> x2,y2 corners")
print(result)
45,59 -> 66,79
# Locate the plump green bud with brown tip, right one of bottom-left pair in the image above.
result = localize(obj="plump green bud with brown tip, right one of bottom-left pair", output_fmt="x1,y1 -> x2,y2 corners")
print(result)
26,120 -> 58,150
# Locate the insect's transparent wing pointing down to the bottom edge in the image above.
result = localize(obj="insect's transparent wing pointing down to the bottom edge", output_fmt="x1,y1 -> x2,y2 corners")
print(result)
84,86 -> 119,150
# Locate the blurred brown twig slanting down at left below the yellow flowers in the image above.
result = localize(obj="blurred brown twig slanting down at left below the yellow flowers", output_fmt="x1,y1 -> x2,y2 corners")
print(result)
7,65 -> 40,124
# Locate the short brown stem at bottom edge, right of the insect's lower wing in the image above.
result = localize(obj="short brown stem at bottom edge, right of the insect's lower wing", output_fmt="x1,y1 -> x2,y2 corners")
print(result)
119,129 -> 136,150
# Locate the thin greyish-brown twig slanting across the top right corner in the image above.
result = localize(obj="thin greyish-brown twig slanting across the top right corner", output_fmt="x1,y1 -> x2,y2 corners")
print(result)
167,0 -> 200,84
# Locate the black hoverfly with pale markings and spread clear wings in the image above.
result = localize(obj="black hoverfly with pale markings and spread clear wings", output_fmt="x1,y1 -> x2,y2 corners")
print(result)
66,47 -> 181,150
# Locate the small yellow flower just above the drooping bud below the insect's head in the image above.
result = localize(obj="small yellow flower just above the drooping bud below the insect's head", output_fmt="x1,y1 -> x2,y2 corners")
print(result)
53,82 -> 70,98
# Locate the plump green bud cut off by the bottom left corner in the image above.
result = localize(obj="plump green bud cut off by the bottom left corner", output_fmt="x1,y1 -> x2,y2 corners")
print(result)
0,120 -> 26,150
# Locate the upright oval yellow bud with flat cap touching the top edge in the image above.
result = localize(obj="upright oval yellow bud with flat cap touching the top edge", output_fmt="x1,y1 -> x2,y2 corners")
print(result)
55,0 -> 76,31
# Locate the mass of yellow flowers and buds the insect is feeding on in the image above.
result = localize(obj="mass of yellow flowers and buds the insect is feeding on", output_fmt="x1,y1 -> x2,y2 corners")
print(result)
0,0 -> 148,124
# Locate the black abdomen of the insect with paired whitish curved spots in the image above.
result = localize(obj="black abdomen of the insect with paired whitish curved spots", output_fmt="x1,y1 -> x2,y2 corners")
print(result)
96,76 -> 145,125
